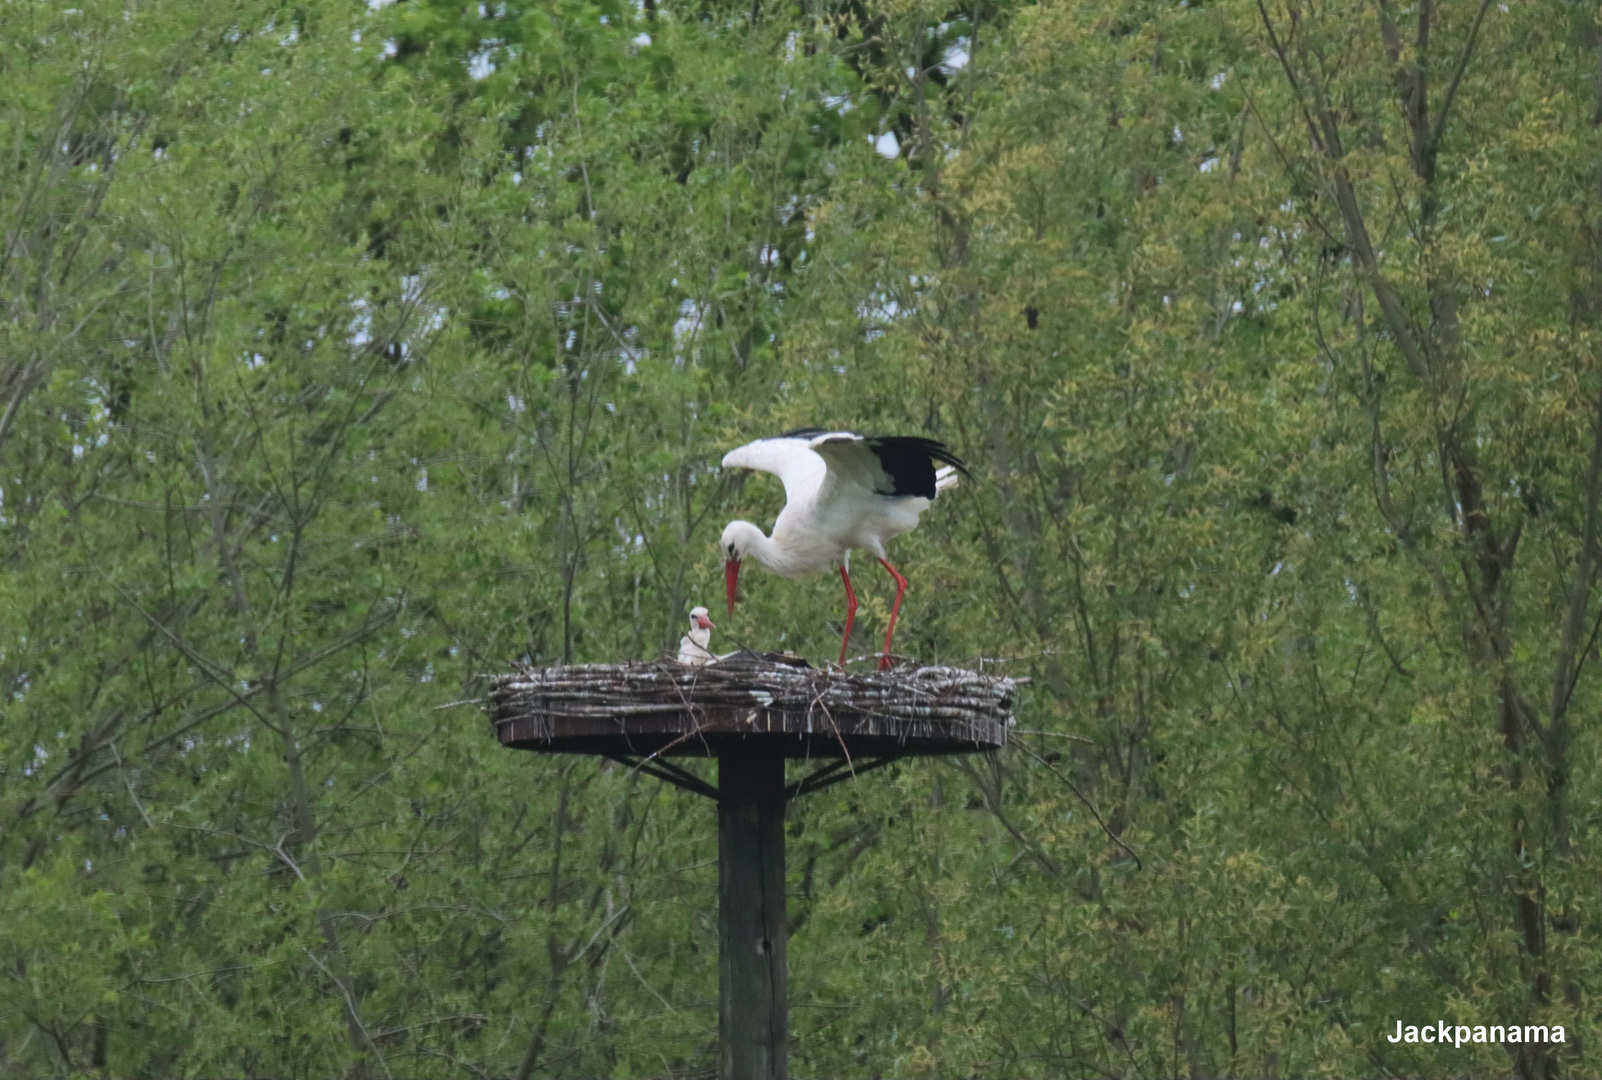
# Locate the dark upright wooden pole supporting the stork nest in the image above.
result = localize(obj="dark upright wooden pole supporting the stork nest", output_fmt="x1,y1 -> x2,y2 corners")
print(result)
718,740 -> 790,1080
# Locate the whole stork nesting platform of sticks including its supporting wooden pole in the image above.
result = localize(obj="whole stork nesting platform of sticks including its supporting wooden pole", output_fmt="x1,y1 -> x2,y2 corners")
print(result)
485,652 -> 1016,1080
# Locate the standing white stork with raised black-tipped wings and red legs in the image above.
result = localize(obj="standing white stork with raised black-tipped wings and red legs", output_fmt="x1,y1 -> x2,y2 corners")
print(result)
718,428 -> 968,671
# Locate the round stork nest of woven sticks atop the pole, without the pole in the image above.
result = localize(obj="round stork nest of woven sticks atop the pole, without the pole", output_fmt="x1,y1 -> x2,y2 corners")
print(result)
487,652 -> 1016,758
